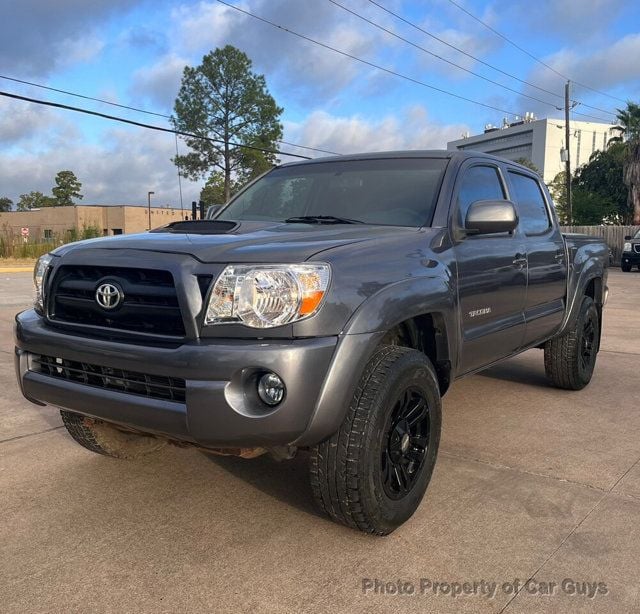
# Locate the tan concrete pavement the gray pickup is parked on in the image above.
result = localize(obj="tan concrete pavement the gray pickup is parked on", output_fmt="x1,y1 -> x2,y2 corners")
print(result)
0,270 -> 640,614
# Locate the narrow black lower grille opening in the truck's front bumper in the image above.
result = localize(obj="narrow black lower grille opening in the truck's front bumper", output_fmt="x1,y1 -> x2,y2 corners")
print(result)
30,355 -> 186,403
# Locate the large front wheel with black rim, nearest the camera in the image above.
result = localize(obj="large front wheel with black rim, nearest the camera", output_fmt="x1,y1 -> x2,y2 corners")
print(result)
310,345 -> 442,535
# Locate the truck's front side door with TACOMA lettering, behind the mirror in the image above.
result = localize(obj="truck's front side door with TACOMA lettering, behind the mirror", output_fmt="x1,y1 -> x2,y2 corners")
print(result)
452,161 -> 527,373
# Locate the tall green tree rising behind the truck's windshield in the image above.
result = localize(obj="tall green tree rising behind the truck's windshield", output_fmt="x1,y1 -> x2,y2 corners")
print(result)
171,45 -> 283,202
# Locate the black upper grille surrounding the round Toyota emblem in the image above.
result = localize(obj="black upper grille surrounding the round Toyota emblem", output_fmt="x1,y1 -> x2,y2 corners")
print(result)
49,265 -> 185,337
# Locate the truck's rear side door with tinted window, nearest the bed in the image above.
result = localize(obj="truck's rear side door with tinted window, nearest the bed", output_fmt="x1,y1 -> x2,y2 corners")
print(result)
507,169 -> 567,346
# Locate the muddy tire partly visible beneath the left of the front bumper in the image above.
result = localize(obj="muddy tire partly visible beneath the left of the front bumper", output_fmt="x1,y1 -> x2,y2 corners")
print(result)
60,410 -> 167,459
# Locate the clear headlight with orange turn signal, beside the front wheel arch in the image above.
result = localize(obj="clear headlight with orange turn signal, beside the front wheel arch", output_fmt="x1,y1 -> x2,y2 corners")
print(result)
205,264 -> 331,328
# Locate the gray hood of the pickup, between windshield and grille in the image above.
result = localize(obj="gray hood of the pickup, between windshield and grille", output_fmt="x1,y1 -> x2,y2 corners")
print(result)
53,220 -> 418,263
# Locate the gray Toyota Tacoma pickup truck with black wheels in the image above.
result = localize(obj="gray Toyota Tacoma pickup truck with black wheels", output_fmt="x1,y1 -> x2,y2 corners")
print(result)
15,151 -> 608,535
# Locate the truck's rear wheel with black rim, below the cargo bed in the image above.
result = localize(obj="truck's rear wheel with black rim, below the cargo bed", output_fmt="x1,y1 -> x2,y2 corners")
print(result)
544,296 -> 600,390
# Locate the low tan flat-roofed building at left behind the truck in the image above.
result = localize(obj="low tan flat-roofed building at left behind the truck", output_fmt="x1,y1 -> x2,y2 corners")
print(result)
0,205 -> 187,241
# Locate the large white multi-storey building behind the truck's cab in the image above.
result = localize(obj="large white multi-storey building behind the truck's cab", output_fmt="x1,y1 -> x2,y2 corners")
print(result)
447,113 -> 617,183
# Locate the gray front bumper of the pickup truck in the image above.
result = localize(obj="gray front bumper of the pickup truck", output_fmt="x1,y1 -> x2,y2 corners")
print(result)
15,310 -> 379,447
